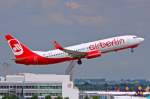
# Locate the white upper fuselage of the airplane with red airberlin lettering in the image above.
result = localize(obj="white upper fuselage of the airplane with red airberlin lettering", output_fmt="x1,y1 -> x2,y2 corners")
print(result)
34,35 -> 144,58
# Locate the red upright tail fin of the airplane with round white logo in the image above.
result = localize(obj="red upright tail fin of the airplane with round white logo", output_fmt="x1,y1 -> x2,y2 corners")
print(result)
5,34 -> 33,59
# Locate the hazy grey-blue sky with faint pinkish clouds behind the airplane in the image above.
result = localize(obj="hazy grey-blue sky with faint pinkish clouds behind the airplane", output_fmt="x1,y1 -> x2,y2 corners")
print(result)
0,0 -> 150,80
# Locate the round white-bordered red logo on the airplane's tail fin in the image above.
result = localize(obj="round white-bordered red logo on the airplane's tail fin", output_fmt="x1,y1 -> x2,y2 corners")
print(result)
8,39 -> 24,56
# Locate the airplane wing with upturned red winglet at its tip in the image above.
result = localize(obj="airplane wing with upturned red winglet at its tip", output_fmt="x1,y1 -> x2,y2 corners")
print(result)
54,41 -> 87,58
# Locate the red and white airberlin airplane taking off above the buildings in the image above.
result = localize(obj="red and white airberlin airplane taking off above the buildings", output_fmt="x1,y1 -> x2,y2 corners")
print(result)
5,33 -> 144,65
